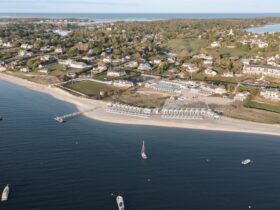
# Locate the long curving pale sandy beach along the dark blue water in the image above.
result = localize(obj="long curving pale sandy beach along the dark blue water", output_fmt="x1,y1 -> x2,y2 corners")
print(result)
0,73 -> 280,136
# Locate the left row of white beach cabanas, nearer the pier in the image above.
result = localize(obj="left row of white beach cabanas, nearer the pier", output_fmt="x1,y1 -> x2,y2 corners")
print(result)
106,103 -> 152,118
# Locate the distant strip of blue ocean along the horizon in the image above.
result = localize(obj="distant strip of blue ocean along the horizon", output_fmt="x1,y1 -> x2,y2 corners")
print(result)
0,13 -> 280,22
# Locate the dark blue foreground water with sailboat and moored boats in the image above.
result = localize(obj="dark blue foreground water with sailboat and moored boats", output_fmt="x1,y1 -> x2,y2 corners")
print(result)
0,81 -> 280,210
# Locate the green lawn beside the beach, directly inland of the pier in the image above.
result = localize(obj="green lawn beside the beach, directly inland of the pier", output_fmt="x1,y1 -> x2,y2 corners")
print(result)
65,81 -> 122,97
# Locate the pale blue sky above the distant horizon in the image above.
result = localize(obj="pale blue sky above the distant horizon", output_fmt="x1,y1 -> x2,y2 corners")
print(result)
0,0 -> 280,13
